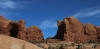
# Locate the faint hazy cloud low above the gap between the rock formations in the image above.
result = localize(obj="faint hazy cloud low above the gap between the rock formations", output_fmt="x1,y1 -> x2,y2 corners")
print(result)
40,20 -> 57,29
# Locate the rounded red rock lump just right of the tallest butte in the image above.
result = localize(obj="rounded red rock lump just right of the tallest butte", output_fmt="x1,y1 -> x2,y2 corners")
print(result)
83,24 -> 98,41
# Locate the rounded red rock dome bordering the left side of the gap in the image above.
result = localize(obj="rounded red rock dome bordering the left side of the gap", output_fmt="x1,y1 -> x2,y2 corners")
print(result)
26,26 -> 43,42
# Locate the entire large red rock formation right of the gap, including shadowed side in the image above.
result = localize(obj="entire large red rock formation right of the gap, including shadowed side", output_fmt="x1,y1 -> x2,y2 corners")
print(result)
54,17 -> 100,42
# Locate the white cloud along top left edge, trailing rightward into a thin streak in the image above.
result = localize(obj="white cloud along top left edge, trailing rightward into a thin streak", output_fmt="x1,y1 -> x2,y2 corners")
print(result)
0,0 -> 38,9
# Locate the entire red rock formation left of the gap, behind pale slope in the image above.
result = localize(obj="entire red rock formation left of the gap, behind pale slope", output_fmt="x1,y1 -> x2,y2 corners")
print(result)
0,16 -> 44,42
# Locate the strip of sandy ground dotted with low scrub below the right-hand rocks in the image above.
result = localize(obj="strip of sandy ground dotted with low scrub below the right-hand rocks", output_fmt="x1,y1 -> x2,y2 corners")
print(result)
33,41 -> 100,49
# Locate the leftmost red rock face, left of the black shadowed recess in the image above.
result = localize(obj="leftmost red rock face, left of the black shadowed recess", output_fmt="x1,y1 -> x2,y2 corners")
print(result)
0,16 -> 10,35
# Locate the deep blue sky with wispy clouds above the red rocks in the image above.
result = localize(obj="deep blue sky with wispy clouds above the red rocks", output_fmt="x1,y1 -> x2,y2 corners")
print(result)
0,0 -> 100,38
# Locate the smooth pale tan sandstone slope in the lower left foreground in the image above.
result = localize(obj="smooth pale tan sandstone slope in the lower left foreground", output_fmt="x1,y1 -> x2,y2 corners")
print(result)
0,34 -> 42,49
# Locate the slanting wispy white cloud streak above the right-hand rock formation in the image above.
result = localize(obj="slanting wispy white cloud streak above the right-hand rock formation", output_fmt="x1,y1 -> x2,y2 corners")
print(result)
73,6 -> 100,18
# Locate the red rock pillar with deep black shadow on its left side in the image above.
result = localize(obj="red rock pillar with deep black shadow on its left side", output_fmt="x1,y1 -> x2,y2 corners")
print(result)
9,20 -> 26,40
